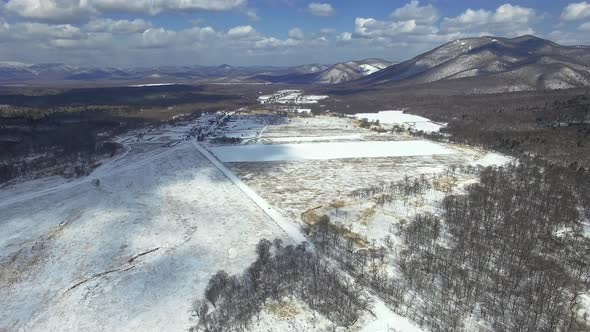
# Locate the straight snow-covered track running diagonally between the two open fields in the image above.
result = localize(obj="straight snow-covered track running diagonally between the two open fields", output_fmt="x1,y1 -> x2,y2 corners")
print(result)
191,141 -> 307,243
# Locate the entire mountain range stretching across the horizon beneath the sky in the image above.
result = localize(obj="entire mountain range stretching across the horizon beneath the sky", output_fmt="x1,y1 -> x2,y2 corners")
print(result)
0,35 -> 590,93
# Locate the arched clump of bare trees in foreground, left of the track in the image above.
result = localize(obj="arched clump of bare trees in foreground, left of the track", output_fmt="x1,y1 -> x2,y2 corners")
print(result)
191,239 -> 370,332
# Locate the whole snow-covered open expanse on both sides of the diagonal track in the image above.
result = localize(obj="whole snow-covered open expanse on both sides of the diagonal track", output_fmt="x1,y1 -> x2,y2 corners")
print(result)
0,114 -> 508,332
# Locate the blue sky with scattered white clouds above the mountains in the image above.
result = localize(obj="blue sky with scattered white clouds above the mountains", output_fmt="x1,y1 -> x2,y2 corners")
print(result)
0,0 -> 590,67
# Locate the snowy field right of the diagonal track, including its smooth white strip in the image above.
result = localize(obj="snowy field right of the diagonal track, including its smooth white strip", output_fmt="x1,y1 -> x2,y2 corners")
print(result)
224,116 -> 510,226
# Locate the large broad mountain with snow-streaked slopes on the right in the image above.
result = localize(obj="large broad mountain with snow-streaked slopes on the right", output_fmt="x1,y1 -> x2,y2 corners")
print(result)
359,36 -> 590,92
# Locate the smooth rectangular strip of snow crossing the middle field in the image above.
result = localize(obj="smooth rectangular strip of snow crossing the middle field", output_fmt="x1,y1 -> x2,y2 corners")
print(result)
209,141 -> 455,162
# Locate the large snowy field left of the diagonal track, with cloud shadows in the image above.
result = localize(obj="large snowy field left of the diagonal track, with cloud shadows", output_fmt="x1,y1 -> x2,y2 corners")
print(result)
0,142 -> 286,331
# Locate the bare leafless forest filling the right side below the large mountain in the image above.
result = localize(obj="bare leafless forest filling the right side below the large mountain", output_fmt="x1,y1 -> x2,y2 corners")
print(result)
199,90 -> 590,332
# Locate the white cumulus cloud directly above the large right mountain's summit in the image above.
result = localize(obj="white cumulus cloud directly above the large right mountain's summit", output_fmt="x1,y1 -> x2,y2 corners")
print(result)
441,4 -> 538,35
